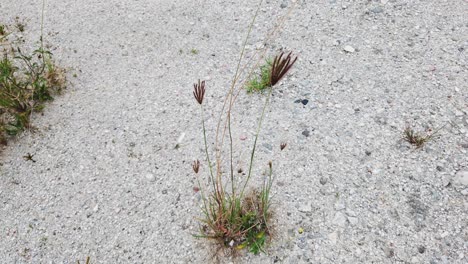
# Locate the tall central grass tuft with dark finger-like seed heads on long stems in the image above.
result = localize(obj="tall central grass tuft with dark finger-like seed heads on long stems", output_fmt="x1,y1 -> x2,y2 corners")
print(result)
192,11 -> 297,254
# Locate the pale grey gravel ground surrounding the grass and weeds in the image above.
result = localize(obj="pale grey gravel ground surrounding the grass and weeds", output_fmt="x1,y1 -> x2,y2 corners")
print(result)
0,0 -> 468,264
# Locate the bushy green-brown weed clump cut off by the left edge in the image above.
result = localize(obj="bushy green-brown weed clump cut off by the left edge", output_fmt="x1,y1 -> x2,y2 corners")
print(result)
0,20 -> 65,144
